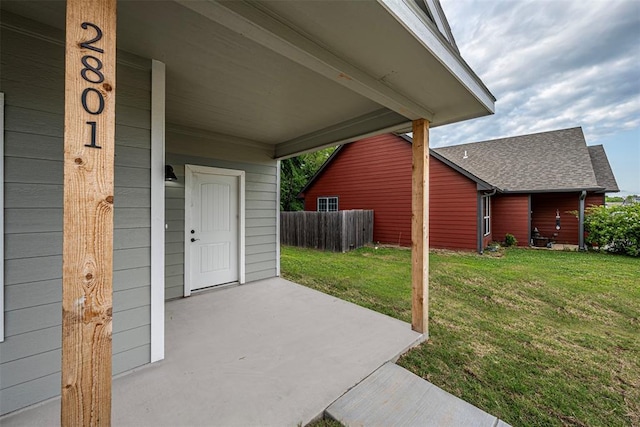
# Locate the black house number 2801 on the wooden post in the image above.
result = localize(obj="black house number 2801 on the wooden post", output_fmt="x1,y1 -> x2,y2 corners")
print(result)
80,22 -> 106,148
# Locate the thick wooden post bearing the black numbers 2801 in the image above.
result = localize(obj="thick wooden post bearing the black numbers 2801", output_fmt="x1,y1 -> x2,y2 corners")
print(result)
61,0 -> 116,426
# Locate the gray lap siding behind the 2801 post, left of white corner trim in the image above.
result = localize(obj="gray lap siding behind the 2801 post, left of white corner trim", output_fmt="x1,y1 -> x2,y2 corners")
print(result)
0,12 -> 151,414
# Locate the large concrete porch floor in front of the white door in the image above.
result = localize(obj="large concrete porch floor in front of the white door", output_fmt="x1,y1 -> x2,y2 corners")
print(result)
1,278 -> 422,427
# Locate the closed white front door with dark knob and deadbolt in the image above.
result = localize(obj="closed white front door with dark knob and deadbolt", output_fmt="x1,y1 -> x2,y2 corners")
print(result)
185,165 -> 241,295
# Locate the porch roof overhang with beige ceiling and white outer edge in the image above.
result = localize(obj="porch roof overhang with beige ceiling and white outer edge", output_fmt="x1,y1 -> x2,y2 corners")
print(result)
1,0 -> 494,157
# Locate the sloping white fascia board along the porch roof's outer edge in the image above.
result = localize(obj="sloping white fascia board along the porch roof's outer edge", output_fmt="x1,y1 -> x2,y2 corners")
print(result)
378,0 -> 496,113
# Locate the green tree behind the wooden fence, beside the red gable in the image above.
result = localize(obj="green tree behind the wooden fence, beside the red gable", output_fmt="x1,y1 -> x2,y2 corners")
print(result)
280,147 -> 337,211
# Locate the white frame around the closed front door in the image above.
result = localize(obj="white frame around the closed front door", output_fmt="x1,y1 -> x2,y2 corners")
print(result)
184,165 -> 245,297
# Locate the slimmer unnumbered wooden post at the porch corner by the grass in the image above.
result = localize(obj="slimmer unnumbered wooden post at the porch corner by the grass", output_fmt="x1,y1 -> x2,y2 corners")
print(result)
411,119 -> 429,336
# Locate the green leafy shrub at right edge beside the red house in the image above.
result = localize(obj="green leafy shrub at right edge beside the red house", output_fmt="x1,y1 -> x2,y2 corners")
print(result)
584,203 -> 640,256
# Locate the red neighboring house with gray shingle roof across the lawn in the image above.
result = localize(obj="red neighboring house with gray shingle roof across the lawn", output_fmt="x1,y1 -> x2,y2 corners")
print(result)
300,128 -> 618,252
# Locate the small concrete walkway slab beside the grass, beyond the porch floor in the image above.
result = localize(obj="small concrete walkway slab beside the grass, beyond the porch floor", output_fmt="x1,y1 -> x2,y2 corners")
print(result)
326,363 -> 508,427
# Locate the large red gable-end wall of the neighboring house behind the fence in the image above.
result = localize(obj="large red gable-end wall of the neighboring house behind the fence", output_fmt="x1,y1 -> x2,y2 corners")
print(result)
304,134 -> 478,250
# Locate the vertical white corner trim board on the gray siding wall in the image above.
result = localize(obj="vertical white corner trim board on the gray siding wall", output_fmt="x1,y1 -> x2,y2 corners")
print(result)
151,60 -> 165,363
